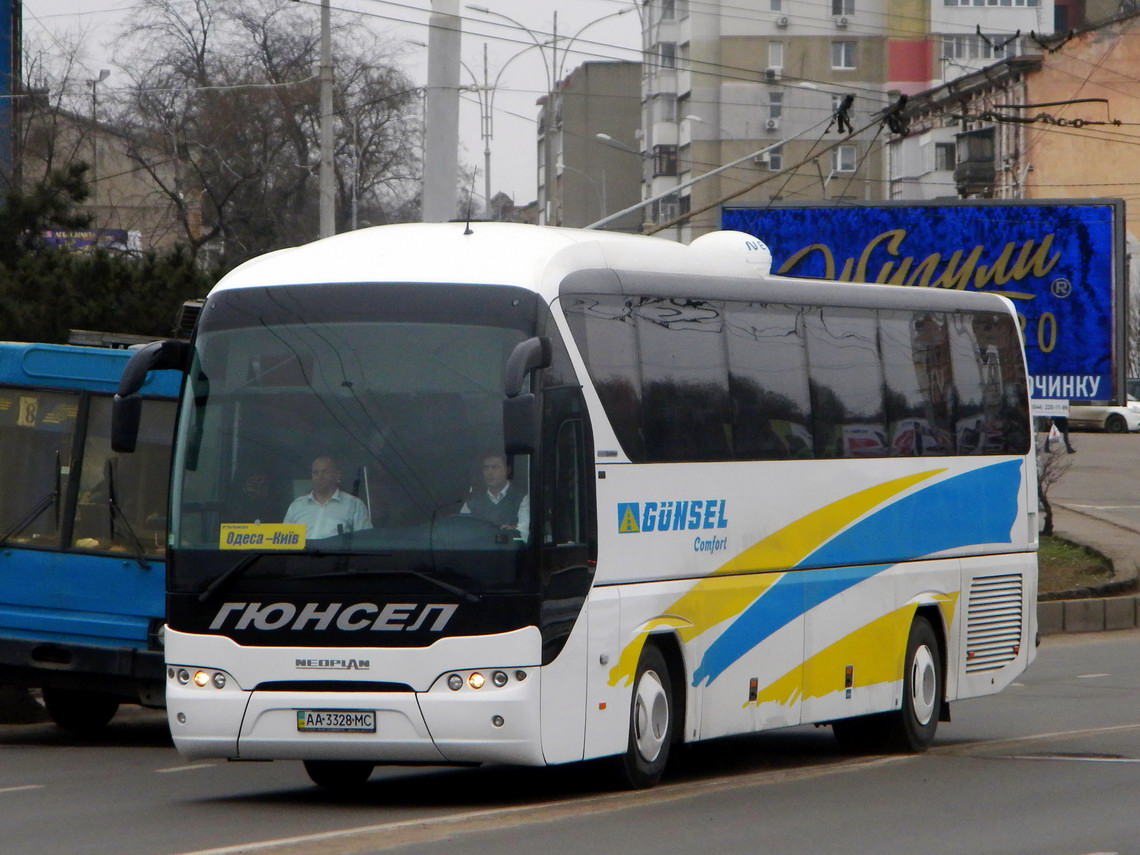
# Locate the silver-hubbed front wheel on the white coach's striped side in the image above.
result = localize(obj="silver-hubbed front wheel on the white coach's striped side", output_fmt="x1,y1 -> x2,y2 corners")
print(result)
619,644 -> 677,790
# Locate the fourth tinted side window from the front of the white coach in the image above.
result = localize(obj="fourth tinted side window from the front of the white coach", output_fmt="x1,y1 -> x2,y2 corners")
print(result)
805,307 -> 887,457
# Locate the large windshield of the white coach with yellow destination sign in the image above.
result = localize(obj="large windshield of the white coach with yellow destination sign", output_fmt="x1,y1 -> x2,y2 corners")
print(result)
171,285 -> 537,593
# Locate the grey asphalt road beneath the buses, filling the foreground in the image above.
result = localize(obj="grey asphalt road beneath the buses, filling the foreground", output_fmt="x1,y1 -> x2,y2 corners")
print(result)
0,632 -> 1140,855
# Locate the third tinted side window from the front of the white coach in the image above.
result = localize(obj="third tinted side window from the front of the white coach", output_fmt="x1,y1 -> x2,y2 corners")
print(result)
725,303 -> 815,461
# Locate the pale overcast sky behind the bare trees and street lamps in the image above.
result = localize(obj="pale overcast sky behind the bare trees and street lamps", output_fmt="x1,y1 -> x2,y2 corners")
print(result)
24,0 -> 641,204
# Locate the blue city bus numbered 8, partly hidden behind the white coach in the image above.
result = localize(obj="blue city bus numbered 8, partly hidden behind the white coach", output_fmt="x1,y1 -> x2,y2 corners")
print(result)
0,342 -> 180,733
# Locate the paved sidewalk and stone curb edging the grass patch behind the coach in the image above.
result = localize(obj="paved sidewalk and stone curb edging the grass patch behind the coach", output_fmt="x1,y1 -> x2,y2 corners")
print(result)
1037,499 -> 1140,635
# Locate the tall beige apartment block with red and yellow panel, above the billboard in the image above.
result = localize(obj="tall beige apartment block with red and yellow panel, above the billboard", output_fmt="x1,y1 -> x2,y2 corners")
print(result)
640,0 -> 1057,241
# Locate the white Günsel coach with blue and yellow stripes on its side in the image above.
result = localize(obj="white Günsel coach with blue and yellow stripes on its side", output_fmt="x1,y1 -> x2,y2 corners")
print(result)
115,223 -> 1037,787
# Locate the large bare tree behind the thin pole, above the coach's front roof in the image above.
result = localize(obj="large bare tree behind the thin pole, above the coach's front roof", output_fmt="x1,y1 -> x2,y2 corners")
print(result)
111,0 -> 420,267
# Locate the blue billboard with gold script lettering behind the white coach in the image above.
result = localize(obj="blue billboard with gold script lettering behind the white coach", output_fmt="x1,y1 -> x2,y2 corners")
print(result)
722,200 -> 1127,400
